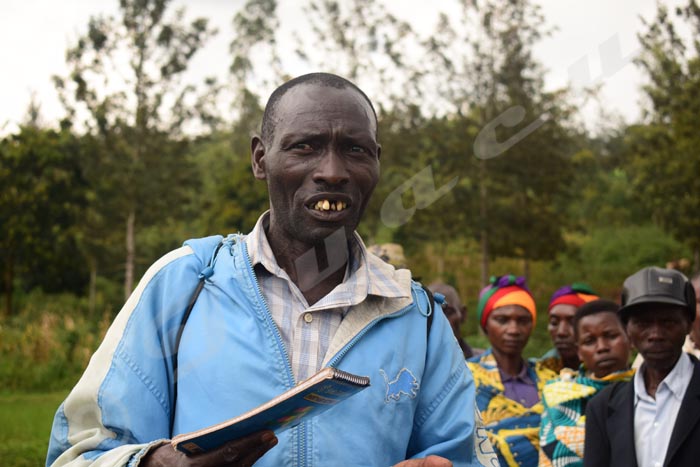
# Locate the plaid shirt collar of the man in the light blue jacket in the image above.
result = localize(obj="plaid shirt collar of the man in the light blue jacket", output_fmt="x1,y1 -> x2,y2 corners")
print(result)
245,211 -> 411,310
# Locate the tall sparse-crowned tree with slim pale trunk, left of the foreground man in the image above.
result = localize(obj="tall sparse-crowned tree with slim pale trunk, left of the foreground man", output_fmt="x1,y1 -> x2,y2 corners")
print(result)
55,0 -> 214,296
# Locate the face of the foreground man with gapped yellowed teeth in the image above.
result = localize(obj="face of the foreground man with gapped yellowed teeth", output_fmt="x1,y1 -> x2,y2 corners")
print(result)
252,84 -> 381,252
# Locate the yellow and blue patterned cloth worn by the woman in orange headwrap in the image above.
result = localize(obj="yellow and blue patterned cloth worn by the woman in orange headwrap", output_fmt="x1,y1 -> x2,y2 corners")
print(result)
467,349 -> 557,467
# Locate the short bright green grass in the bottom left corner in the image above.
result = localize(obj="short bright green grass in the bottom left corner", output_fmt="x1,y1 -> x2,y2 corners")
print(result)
0,391 -> 67,467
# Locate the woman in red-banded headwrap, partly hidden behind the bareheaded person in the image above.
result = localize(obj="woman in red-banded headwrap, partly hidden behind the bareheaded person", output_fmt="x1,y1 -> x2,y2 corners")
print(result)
542,282 -> 598,373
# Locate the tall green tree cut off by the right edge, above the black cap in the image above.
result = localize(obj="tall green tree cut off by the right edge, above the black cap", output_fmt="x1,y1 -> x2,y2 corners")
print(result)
627,0 -> 700,270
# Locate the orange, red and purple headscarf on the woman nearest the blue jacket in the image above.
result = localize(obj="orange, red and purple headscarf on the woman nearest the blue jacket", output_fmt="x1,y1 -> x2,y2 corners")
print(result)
476,274 -> 537,328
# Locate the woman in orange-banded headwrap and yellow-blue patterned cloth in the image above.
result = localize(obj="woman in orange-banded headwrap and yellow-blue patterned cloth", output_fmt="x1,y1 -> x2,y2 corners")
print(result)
467,275 -> 556,467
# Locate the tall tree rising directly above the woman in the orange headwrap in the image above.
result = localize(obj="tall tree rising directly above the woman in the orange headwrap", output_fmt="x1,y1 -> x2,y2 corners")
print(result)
418,0 -> 577,281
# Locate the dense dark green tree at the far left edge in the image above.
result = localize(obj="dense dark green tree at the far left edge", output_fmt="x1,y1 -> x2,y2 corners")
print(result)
0,126 -> 87,315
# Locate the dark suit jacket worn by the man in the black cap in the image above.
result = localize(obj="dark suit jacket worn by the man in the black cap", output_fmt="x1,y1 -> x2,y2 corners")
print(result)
583,357 -> 700,467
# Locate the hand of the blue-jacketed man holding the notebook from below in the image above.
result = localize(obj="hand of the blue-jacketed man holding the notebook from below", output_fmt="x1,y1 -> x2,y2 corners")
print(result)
139,431 -> 277,467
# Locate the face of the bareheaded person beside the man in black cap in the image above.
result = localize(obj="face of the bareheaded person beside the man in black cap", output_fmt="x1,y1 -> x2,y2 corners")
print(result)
578,311 -> 630,378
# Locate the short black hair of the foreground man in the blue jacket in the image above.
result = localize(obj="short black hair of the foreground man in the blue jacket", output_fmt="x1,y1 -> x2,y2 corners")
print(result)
260,73 -> 379,143
